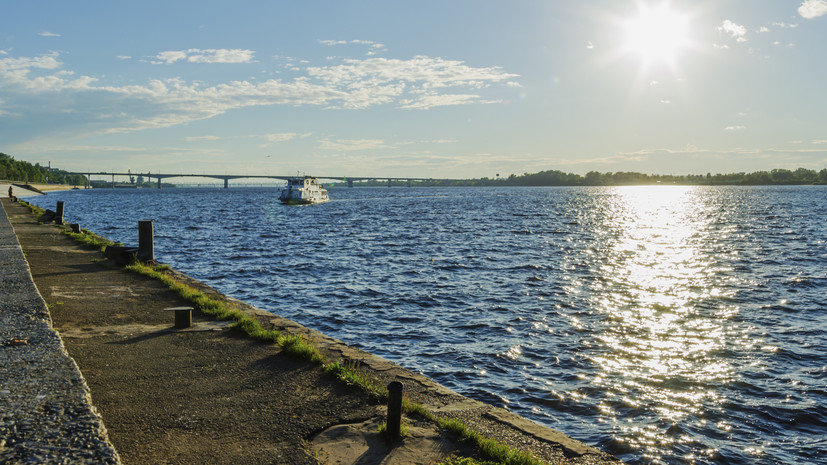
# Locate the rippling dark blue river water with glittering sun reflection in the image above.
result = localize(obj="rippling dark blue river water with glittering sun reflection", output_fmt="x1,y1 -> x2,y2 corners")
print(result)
27,186 -> 827,464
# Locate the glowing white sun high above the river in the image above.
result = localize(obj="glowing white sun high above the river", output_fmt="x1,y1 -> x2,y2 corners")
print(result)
624,2 -> 690,65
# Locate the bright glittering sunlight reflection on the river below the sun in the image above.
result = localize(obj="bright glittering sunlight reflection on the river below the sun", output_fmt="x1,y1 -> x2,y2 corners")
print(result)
576,186 -> 739,460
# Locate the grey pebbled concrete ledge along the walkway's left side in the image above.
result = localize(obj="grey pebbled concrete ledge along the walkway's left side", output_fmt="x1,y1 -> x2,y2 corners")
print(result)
0,198 -> 120,464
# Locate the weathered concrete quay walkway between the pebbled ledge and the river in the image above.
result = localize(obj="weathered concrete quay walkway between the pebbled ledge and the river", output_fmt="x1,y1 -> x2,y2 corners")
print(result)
0,200 -> 620,464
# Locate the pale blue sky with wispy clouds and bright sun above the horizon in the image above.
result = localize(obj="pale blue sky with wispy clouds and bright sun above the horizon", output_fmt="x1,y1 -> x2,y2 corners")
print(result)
0,0 -> 827,177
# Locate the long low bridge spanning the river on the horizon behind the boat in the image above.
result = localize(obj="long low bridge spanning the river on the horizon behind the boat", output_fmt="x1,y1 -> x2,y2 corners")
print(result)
67,171 -> 469,189
